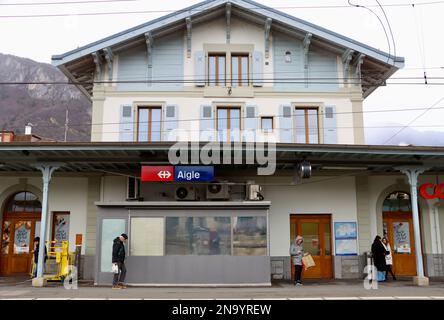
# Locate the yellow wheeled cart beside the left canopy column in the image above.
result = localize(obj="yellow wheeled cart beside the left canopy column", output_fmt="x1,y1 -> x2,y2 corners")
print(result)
30,241 -> 74,282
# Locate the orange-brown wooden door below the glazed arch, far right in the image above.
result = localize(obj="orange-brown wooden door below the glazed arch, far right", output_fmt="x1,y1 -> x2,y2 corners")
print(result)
383,212 -> 416,276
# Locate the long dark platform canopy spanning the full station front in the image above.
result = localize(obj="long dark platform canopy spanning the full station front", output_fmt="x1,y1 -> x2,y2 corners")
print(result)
0,142 -> 444,175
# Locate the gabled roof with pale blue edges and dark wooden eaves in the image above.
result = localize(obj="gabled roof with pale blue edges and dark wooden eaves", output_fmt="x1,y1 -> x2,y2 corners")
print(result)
52,0 -> 404,97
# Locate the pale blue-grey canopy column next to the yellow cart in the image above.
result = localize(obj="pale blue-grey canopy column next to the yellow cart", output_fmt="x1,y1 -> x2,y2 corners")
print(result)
32,164 -> 60,287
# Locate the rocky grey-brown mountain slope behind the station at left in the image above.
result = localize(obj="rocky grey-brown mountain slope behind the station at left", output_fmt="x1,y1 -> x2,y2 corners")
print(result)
0,53 -> 91,141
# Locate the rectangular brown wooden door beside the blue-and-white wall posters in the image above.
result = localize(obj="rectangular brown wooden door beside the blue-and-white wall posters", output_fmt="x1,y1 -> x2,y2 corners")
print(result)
290,214 -> 333,279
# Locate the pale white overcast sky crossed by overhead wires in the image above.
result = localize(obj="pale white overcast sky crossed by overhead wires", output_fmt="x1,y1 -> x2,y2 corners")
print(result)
0,0 -> 444,141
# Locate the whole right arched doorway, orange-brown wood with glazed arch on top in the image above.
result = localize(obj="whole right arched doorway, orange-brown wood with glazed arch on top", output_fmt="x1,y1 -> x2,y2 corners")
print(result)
382,191 -> 416,276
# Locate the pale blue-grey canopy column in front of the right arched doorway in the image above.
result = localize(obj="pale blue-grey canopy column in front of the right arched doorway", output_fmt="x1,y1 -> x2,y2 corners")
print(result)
397,167 -> 429,286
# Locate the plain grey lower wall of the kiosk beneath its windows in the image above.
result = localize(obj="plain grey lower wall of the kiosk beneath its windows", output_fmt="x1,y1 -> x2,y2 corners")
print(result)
99,256 -> 270,285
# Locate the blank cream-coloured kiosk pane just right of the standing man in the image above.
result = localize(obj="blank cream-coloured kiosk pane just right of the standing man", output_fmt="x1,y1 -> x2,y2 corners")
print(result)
130,218 -> 165,256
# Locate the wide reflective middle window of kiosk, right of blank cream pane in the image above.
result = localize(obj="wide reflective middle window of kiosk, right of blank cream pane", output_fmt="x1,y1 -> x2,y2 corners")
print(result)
166,217 -> 231,255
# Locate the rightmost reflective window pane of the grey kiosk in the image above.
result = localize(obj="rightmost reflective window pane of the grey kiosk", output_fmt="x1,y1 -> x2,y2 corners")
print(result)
233,217 -> 267,256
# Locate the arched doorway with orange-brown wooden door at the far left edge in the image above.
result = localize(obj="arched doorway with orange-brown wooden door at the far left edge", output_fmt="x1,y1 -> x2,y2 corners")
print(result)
0,191 -> 42,275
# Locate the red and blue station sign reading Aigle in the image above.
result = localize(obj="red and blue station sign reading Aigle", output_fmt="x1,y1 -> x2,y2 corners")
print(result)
140,166 -> 214,182
